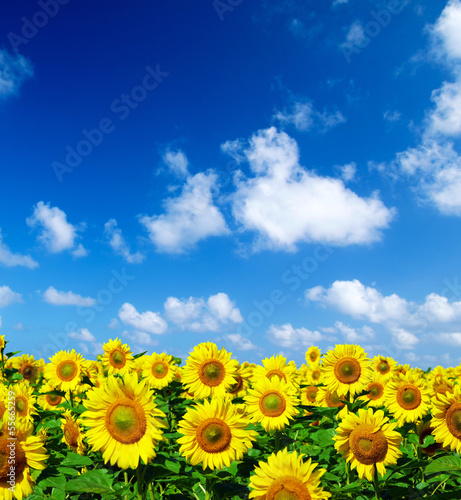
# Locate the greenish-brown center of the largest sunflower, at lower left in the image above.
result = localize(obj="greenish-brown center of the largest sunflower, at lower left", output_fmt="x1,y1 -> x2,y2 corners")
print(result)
105,398 -> 147,444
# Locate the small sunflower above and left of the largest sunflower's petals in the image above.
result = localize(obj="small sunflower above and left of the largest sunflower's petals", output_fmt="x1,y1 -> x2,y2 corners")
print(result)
45,349 -> 83,391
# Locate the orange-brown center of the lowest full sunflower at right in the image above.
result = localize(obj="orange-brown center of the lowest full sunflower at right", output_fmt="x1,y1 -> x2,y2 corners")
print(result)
349,424 -> 389,465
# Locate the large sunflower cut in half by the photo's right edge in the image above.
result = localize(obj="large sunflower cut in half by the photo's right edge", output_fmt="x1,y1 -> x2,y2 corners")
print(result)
431,385 -> 461,453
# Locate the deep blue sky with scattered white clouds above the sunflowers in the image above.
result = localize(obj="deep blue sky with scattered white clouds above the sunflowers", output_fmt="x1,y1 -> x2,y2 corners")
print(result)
0,0 -> 461,368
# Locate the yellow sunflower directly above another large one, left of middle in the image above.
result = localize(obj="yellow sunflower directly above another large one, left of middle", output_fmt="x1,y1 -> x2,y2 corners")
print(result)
181,342 -> 238,399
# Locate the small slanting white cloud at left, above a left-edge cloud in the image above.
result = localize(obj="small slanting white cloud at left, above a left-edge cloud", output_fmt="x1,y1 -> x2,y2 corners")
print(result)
26,201 -> 87,257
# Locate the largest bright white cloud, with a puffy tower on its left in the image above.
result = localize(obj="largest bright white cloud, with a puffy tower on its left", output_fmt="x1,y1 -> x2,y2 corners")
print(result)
223,127 -> 395,251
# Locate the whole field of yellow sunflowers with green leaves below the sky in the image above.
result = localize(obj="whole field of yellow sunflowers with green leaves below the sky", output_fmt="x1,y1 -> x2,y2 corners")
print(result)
0,336 -> 461,500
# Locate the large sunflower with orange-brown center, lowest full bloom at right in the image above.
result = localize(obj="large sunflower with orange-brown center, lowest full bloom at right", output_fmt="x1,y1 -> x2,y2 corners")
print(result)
334,408 -> 402,481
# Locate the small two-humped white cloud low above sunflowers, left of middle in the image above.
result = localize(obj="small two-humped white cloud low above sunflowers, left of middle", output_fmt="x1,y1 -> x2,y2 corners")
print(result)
164,292 -> 243,332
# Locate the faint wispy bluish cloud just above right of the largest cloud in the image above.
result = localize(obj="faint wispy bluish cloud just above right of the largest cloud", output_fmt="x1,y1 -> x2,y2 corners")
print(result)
272,101 -> 346,132
